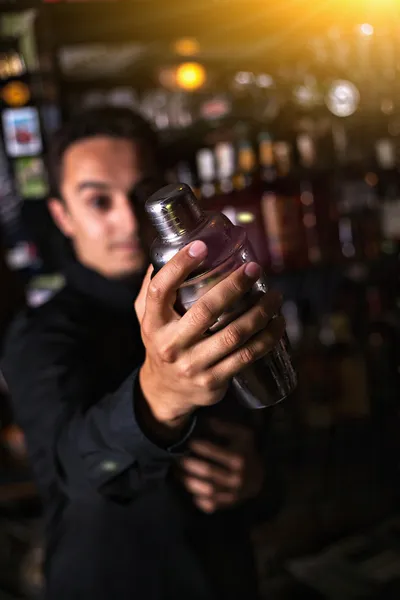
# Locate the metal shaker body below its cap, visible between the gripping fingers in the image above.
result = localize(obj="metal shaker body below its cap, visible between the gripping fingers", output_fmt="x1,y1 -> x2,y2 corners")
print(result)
151,213 -> 297,409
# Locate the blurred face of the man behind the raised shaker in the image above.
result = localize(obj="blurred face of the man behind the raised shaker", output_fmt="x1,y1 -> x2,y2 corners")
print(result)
49,136 -> 158,278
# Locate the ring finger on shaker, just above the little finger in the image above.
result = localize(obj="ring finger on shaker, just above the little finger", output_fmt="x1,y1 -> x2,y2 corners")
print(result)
191,292 -> 281,372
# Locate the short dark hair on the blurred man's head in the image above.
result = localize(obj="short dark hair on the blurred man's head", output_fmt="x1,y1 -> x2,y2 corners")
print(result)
48,106 -> 159,197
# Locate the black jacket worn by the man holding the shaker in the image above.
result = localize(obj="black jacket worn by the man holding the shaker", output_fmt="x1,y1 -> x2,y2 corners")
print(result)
2,263 -> 277,600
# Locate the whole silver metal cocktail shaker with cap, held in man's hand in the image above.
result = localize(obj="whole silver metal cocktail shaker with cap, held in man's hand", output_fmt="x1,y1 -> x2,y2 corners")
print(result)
146,184 -> 297,408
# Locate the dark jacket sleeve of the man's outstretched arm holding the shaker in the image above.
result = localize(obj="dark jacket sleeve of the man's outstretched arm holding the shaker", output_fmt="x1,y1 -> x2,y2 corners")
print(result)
2,312 -> 193,499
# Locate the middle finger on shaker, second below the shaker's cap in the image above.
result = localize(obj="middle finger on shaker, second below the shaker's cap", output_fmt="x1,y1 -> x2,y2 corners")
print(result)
179,262 -> 261,347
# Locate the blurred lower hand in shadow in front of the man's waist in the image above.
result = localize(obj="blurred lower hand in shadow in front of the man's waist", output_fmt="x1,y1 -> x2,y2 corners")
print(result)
181,419 -> 264,513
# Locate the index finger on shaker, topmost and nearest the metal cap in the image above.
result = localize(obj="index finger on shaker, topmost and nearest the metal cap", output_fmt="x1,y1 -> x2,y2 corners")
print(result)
146,240 -> 207,328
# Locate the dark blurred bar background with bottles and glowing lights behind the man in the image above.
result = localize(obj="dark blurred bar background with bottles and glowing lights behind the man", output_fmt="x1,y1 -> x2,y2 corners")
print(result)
0,0 -> 400,600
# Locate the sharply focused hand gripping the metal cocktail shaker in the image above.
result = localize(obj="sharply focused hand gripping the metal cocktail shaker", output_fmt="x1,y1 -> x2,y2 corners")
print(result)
135,241 -> 285,425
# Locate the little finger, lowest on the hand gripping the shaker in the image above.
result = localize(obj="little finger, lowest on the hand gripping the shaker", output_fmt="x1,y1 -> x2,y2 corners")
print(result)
210,317 -> 285,384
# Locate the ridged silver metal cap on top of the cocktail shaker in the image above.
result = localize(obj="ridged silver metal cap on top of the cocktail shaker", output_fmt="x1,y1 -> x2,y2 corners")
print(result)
145,183 -> 205,240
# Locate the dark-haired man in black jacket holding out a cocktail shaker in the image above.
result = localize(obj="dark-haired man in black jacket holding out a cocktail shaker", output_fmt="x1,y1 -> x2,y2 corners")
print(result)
4,109 -> 284,600
